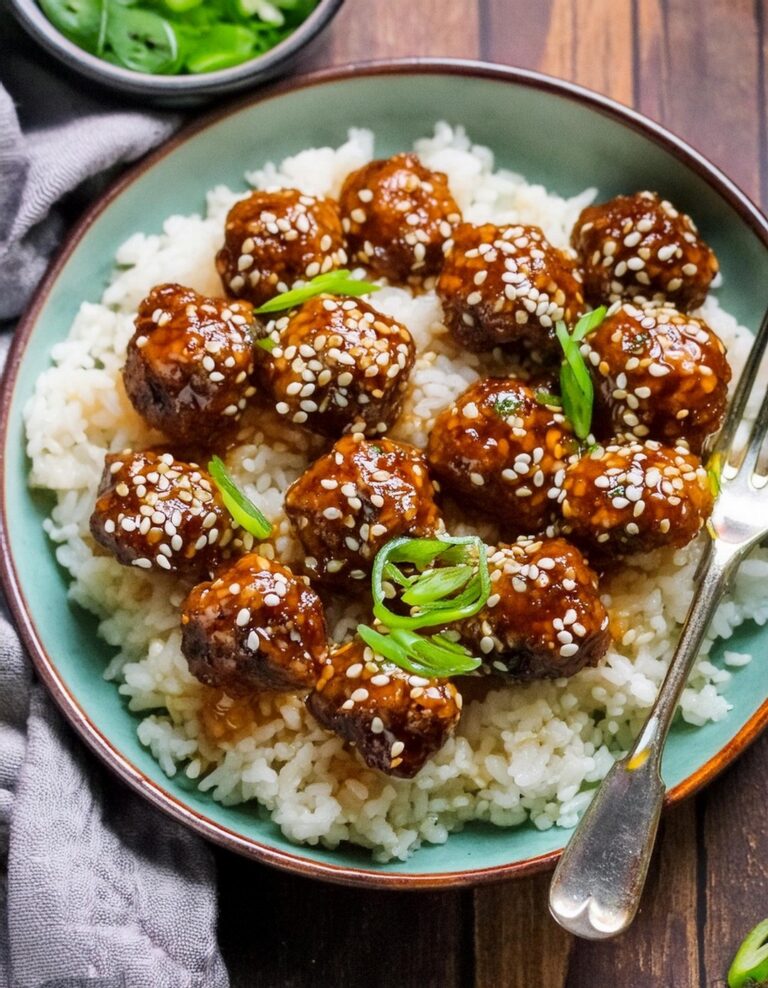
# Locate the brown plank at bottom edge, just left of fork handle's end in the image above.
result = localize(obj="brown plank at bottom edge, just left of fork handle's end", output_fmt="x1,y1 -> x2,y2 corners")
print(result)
475,874 -> 572,988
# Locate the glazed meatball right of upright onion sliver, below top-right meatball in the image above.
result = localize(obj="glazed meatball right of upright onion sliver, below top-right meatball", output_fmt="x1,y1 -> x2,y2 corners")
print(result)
582,302 -> 731,452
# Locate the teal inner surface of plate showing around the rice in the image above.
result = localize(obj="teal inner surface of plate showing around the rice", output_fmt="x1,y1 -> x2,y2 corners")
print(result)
4,68 -> 768,881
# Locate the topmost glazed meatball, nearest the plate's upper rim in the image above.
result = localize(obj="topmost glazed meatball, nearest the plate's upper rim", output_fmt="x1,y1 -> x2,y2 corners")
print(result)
339,154 -> 461,282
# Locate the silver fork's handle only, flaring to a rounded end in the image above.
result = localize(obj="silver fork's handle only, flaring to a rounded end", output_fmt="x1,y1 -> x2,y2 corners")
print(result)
549,542 -> 735,940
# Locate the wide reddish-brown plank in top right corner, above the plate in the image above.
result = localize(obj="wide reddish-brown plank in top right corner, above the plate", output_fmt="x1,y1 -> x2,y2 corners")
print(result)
637,0 -> 764,197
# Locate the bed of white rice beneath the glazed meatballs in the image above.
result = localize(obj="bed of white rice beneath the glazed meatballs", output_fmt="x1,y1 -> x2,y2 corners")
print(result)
26,124 -> 768,861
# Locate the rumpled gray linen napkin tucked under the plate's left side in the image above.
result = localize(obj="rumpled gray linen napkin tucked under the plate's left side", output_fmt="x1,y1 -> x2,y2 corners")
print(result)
0,17 -> 229,988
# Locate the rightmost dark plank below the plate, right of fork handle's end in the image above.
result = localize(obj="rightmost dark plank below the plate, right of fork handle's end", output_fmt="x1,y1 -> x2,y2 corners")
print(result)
701,732 -> 768,984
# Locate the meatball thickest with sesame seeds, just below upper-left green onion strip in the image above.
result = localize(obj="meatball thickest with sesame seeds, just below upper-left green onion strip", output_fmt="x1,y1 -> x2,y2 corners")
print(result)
258,295 -> 415,437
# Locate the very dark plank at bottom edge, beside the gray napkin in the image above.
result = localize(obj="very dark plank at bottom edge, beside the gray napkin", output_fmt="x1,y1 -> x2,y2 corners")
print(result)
218,851 -> 472,988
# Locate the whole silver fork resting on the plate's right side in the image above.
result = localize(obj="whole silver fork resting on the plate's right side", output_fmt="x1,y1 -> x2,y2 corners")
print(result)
549,313 -> 768,940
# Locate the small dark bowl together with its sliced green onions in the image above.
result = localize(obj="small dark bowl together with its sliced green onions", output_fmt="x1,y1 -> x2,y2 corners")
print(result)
10,0 -> 343,106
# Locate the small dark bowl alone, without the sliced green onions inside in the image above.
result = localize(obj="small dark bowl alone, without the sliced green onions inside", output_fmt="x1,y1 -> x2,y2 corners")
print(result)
10,0 -> 344,106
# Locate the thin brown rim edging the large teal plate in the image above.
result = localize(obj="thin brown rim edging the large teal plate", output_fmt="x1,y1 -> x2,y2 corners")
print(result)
0,58 -> 768,890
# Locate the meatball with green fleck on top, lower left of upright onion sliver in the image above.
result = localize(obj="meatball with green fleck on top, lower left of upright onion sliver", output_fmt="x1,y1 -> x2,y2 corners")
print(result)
427,377 -> 577,532
